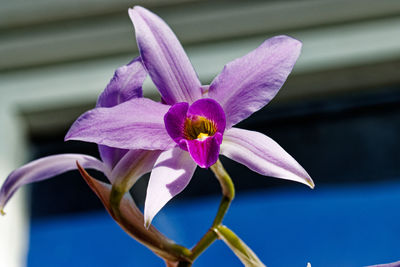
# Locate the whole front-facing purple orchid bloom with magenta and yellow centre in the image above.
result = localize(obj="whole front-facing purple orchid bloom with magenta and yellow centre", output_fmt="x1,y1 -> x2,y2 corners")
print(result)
65,7 -> 314,226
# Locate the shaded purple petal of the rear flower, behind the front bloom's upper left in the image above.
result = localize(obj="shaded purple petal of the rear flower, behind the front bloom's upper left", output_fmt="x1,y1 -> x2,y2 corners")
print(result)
97,57 -> 147,108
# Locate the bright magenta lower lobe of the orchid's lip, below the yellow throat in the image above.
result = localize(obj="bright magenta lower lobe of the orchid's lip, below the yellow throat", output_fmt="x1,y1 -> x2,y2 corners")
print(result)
185,133 -> 222,168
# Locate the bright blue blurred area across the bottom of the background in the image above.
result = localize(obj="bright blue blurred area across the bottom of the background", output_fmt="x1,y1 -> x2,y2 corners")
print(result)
28,182 -> 400,267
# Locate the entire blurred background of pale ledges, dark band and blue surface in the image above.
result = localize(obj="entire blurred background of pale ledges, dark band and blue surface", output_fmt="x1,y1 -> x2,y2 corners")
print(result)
0,0 -> 400,267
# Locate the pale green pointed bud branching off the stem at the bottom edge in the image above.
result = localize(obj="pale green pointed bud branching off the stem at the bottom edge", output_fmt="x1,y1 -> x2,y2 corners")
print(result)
214,225 -> 265,267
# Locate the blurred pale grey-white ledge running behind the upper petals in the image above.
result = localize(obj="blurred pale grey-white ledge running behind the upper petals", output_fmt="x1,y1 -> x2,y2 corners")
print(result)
0,14 -> 400,112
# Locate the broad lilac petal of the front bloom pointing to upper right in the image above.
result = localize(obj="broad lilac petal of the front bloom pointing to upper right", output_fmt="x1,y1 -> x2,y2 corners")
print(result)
208,36 -> 301,129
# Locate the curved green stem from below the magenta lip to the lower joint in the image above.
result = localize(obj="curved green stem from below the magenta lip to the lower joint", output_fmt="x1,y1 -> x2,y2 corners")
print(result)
190,160 -> 235,261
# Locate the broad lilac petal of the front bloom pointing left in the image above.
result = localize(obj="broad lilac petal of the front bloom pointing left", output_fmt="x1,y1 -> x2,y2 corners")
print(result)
65,98 -> 175,153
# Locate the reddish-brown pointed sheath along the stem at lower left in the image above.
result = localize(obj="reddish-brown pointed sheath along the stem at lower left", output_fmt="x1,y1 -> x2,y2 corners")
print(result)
77,163 -> 181,260
